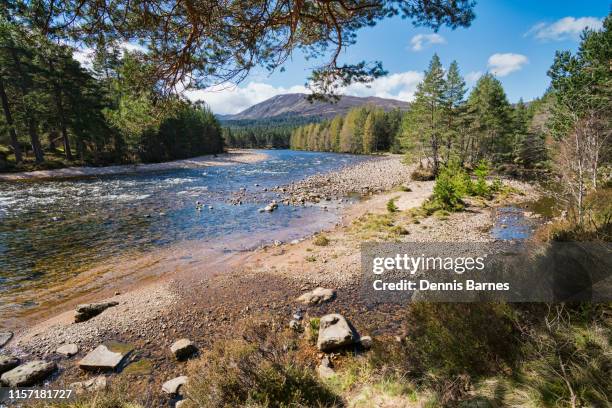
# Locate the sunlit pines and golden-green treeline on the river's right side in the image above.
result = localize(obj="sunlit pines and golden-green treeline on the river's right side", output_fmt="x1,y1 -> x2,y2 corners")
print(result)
290,55 -> 546,174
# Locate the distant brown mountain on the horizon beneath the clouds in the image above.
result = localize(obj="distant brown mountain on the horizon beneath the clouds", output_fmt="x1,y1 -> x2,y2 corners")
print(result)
219,93 -> 409,121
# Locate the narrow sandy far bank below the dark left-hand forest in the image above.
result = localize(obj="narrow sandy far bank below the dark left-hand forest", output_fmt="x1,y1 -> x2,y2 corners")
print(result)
0,149 -> 267,181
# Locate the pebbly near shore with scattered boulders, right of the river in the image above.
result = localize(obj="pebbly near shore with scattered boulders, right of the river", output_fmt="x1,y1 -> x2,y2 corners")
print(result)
0,156 -> 537,406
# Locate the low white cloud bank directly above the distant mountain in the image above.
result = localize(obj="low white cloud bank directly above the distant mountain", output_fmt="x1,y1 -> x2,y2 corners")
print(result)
185,71 -> 423,115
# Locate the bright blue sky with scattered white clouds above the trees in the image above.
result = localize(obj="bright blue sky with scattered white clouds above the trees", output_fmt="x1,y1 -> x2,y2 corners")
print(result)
188,0 -> 610,114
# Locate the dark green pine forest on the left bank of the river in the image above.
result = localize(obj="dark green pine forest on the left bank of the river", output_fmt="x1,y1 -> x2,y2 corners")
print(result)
0,16 -> 223,170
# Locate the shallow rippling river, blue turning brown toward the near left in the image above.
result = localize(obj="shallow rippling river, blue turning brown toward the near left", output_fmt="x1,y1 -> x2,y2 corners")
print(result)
0,150 -> 365,327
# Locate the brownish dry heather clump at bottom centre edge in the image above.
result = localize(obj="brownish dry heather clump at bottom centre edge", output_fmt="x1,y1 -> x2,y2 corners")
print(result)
186,323 -> 342,408
